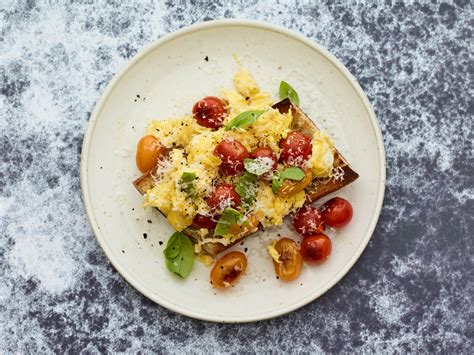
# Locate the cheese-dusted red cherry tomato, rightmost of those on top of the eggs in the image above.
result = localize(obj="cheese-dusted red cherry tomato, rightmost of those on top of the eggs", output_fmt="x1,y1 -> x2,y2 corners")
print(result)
280,131 -> 312,166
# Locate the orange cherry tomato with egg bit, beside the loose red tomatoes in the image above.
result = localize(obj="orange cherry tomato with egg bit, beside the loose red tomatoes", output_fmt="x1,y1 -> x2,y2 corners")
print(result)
273,238 -> 303,281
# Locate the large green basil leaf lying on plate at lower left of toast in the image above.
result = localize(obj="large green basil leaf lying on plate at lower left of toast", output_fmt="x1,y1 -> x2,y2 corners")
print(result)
163,232 -> 194,279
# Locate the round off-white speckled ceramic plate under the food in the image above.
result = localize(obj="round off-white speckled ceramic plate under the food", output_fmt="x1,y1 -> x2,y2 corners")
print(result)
81,21 -> 385,322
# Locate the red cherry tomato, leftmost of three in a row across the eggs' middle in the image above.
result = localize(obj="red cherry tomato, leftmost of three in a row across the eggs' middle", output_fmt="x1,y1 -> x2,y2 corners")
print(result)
214,138 -> 249,175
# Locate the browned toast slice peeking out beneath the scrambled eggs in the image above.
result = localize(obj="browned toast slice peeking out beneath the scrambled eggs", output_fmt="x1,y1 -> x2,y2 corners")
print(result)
133,99 -> 359,256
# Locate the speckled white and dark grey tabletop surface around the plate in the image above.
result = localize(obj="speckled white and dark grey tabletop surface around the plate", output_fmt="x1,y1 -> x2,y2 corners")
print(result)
0,1 -> 474,353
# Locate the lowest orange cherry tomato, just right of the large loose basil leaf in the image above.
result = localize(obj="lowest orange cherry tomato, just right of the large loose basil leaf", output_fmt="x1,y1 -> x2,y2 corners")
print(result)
211,251 -> 247,288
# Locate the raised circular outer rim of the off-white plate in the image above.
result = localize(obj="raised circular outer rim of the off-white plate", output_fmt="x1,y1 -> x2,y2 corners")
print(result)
80,19 -> 387,323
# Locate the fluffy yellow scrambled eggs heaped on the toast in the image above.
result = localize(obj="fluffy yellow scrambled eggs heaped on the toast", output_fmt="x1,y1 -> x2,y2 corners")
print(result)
144,68 -> 334,234
